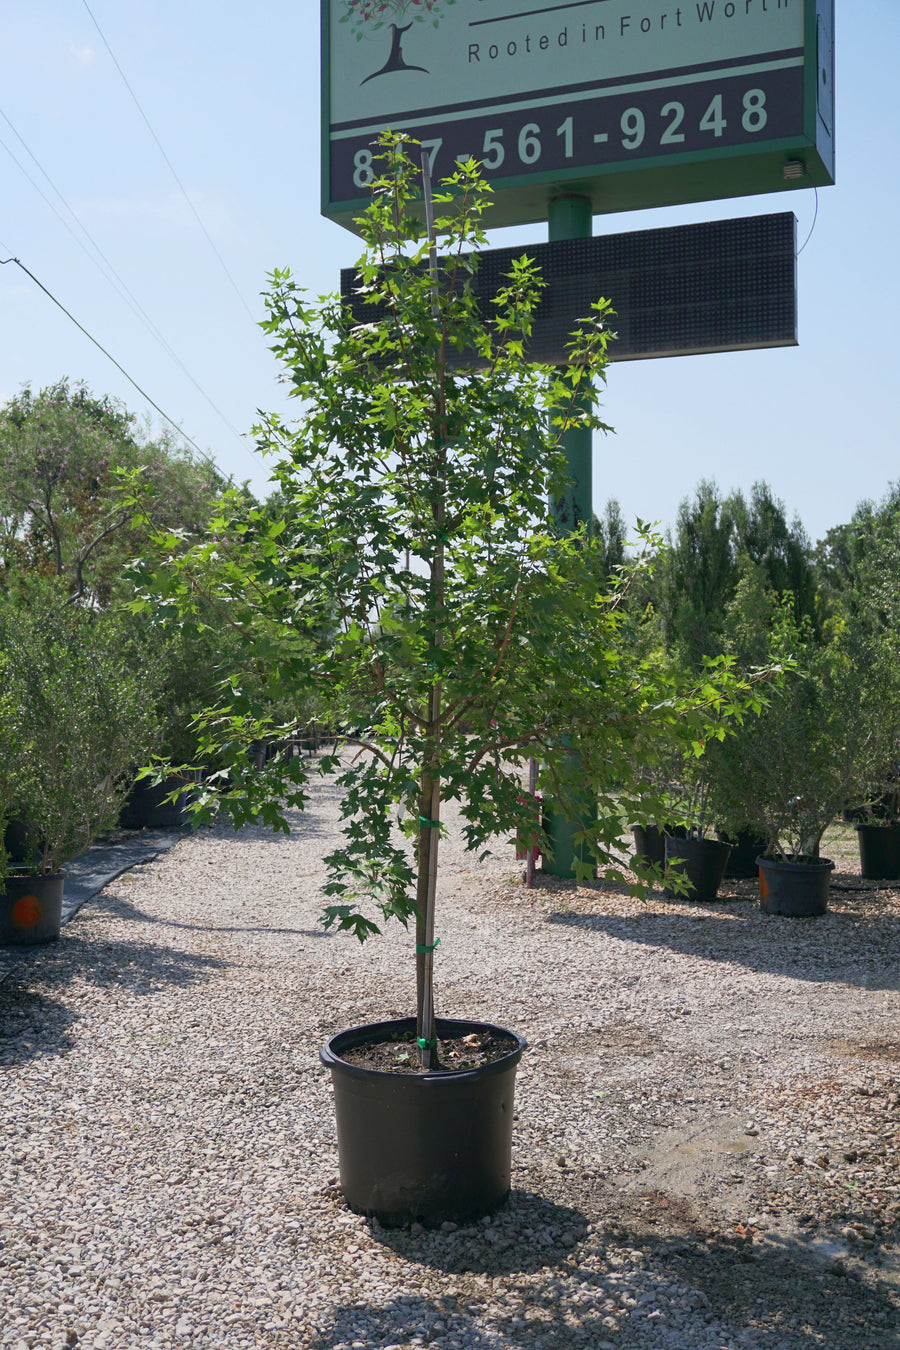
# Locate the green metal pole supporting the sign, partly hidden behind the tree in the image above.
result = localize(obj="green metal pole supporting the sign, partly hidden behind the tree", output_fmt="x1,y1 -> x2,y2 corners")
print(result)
544,196 -> 594,878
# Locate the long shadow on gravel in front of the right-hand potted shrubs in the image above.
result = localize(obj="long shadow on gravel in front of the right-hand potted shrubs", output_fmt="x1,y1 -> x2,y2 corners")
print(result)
546,896 -> 900,990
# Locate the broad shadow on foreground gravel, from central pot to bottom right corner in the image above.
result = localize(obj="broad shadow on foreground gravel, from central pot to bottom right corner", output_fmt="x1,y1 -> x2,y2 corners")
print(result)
308,1192 -> 897,1350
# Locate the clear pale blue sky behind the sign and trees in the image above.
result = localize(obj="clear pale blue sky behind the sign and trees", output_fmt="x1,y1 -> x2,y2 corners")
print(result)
0,0 -> 900,540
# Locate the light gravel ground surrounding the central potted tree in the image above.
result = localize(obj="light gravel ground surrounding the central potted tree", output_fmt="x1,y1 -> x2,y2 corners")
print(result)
0,783 -> 900,1350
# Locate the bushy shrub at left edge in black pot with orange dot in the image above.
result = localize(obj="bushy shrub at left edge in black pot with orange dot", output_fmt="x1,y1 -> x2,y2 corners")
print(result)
0,582 -> 155,945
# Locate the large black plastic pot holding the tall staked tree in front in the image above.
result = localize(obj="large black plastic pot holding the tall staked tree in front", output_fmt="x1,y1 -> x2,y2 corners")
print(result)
318,1018 -> 526,1226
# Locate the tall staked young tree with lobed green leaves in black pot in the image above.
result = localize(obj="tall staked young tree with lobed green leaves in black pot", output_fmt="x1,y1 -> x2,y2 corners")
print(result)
138,138 -> 766,1222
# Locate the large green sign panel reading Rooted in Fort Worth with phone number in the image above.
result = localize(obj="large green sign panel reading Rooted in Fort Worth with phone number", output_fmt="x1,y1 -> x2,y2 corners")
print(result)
322,0 -> 834,230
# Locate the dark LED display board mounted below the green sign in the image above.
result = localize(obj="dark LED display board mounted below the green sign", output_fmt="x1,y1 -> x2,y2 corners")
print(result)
340,212 -> 797,365
